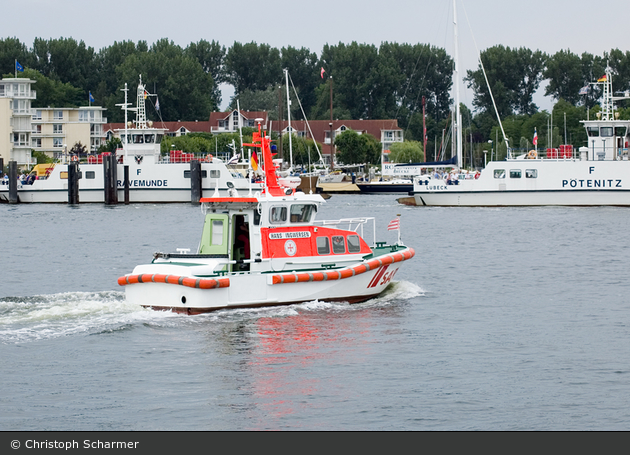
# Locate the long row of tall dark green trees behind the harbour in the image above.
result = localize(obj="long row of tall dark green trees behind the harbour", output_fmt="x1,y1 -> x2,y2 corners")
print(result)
0,37 -> 630,167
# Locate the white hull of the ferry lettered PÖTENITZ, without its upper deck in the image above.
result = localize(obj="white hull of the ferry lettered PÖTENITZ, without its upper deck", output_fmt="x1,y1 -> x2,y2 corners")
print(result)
411,159 -> 630,207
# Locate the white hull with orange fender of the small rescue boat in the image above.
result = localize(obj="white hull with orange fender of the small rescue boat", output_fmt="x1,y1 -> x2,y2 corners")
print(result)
119,248 -> 415,314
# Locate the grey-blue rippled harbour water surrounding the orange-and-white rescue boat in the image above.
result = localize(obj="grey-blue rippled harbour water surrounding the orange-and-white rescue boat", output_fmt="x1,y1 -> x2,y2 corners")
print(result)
0,195 -> 630,431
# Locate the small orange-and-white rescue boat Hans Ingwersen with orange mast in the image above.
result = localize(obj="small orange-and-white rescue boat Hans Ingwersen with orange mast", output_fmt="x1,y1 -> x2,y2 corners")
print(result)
118,125 -> 415,314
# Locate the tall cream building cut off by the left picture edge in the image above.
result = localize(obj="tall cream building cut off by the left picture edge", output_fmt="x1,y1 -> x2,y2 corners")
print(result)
0,78 -> 37,166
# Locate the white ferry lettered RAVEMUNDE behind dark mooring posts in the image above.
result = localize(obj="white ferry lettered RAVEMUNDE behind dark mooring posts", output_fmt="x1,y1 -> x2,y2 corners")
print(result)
0,78 -> 262,203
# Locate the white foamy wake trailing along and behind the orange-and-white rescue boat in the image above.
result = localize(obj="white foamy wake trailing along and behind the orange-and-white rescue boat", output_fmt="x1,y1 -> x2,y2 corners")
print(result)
0,281 -> 425,344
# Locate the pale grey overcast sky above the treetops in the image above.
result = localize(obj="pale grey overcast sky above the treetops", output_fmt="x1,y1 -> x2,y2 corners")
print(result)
6,0 -> 630,109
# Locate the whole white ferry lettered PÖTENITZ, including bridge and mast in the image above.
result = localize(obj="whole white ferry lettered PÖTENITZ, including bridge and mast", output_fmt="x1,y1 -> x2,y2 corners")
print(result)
405,68 -> 630,206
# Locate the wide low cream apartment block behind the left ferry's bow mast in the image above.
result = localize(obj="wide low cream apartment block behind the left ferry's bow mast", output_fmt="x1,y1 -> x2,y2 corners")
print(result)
31,106 -> 107,158
